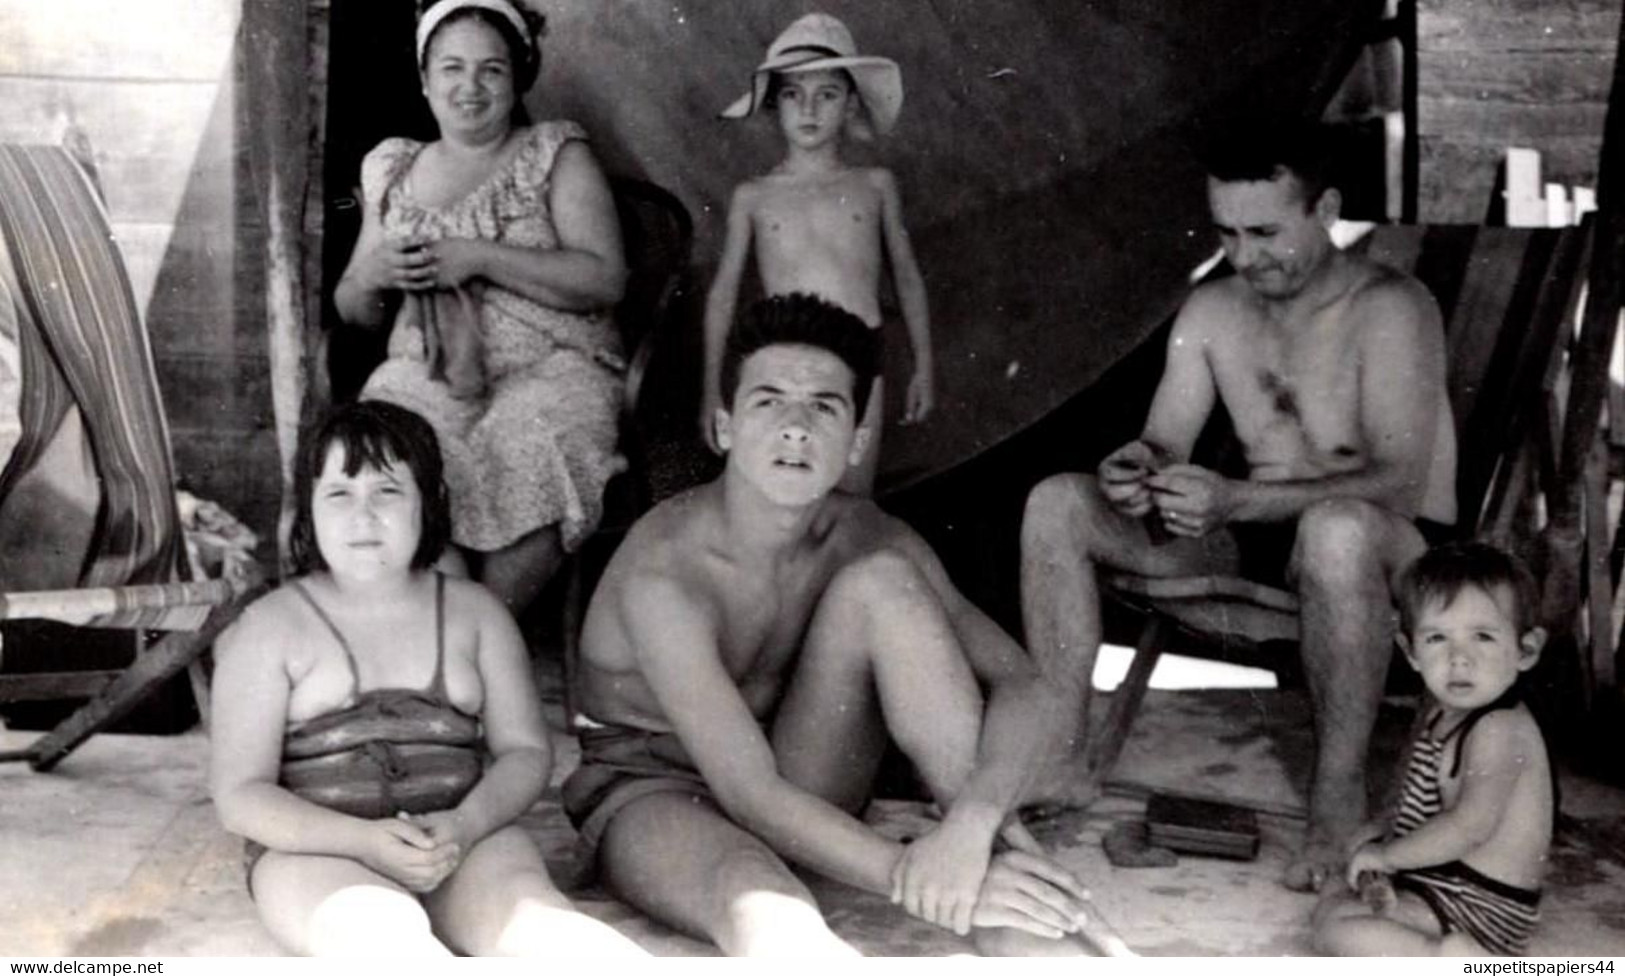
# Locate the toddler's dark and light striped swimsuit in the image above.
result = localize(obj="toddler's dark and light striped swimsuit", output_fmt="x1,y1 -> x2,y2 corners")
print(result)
1394,689 -> 1541,955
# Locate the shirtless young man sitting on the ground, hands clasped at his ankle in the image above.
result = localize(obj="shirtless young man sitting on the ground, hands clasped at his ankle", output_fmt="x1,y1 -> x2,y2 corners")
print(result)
564,294 -> 1087,957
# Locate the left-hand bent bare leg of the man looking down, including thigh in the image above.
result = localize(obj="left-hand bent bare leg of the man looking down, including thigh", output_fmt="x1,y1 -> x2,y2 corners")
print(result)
1021,474 -> 1235,805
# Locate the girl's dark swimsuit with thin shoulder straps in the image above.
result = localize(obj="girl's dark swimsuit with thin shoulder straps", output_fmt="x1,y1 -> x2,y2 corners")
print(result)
244,575 -> 486,879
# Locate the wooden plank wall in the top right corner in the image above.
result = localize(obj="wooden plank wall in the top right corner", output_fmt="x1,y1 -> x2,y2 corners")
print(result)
1417,0 -> 1620,222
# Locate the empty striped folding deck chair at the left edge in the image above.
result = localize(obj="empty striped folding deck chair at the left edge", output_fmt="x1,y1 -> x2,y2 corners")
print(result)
0,146 -> 252,770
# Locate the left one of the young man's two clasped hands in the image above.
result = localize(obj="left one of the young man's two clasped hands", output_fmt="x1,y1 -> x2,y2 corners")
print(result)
892,815 -> 993,935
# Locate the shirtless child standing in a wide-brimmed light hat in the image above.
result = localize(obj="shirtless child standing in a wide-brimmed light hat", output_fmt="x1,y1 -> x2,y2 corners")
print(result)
700,13 -> 936,494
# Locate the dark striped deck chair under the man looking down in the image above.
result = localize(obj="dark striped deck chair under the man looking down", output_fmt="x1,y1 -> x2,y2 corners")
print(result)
1090,224 -> 1589,783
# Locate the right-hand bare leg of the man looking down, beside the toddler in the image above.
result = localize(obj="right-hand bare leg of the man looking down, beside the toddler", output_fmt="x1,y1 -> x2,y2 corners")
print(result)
1282,500 -> 1425,890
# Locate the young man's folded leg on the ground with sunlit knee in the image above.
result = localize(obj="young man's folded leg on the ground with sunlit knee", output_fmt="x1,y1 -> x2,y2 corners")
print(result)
600,792 -> 858,958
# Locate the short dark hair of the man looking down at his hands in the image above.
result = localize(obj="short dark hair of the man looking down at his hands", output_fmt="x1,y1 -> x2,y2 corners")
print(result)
1196,119 -> 1333,209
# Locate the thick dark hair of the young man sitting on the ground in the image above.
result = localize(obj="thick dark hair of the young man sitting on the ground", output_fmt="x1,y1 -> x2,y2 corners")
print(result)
722,292 -> 881,424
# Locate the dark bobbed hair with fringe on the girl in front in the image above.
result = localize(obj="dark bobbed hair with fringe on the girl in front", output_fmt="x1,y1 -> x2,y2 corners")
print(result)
288,399 -> 452,573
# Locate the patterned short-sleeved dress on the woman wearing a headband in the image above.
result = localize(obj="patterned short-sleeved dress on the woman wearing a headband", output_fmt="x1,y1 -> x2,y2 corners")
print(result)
361,122 -> 626,552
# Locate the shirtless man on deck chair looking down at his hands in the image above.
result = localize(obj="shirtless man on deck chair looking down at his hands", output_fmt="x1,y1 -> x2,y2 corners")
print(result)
1022,120 -> 1456,890
